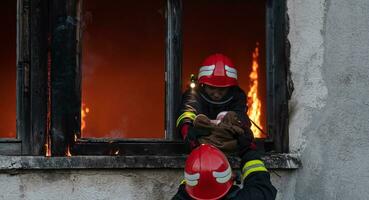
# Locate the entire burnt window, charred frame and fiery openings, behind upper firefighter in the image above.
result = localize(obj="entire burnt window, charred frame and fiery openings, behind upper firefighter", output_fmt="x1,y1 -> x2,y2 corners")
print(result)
0,0 -> 292,156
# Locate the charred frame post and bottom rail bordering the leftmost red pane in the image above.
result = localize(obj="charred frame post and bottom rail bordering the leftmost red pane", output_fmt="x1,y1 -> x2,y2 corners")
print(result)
0,0 -> 47,155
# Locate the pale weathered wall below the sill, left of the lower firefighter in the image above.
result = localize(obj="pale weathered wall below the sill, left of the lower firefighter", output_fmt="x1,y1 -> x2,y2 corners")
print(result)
0,170 -> 182,200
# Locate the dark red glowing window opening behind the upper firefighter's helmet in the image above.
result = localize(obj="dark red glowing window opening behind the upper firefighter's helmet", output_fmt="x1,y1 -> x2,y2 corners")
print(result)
182,0 -> 267,137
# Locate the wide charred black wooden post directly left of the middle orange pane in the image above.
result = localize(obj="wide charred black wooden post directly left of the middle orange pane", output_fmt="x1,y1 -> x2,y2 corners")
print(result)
50,0 -> 81,156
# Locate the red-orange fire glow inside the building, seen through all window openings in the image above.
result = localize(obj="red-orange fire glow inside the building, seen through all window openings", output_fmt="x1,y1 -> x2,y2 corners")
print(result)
0,0 -> 267,152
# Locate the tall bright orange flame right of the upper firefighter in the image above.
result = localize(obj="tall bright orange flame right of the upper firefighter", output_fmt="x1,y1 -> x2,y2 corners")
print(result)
247,43 -> 265,138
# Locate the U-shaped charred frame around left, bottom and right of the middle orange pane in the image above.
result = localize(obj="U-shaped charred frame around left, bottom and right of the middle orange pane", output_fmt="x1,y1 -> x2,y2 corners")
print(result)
50,0 -> 185,156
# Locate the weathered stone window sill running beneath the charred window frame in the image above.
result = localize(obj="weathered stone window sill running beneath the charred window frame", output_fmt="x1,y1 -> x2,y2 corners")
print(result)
0,154 -> 302,171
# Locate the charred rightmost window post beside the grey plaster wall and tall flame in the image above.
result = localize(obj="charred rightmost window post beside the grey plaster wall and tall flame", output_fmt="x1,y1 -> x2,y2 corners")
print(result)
266,0 -> 293,153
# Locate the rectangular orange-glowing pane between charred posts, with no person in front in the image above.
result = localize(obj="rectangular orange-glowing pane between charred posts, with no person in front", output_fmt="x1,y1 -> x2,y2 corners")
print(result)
81,0 -> 165,138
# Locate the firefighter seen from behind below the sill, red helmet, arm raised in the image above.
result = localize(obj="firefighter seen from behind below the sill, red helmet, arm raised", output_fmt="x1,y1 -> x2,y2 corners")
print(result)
172,134 -> 277,200
